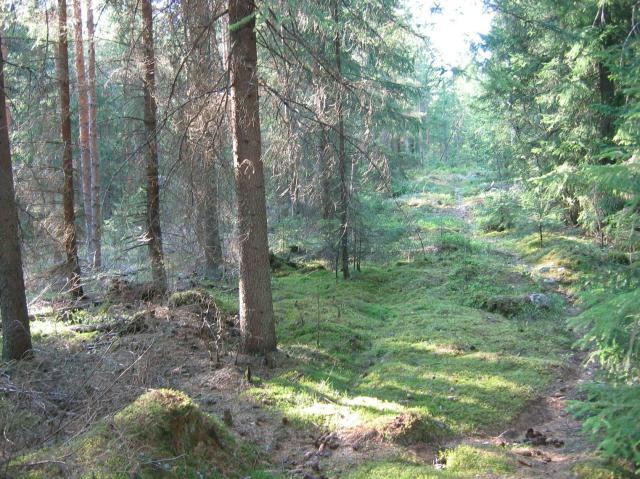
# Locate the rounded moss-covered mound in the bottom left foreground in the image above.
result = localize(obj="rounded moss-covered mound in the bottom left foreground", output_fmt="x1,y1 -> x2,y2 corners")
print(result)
11,389 -> 271,479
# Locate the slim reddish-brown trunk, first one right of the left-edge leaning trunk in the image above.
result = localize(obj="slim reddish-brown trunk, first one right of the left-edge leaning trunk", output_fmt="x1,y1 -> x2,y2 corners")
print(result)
57,0 -> 84,298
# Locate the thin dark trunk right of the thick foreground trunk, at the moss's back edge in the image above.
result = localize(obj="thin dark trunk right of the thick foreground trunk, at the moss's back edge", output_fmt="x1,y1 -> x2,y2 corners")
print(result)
333,0 -> 349,279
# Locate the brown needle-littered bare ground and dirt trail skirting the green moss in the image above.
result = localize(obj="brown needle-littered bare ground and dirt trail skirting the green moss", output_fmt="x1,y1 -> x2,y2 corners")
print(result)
0,178 -> 593,479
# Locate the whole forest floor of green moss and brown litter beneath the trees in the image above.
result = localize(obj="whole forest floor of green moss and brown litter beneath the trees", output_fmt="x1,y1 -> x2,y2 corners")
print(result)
0,172 -> 632,479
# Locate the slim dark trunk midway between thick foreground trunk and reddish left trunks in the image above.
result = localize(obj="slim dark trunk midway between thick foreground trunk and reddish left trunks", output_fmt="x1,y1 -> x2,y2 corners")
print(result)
142,0 -> 167,292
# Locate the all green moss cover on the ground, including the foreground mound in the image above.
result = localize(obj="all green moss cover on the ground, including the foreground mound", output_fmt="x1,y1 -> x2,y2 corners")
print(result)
0,171 -> 632,479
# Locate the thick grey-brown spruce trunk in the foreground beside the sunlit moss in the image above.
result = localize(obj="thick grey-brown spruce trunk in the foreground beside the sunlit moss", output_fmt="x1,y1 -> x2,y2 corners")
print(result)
229,0 -> 276,353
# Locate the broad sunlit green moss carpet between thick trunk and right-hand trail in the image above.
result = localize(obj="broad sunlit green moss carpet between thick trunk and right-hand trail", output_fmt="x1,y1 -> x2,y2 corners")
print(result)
251,172 -> 573,458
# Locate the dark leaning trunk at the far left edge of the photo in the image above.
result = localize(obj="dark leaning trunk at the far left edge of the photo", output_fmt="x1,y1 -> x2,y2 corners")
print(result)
0,32 -> 31,361
